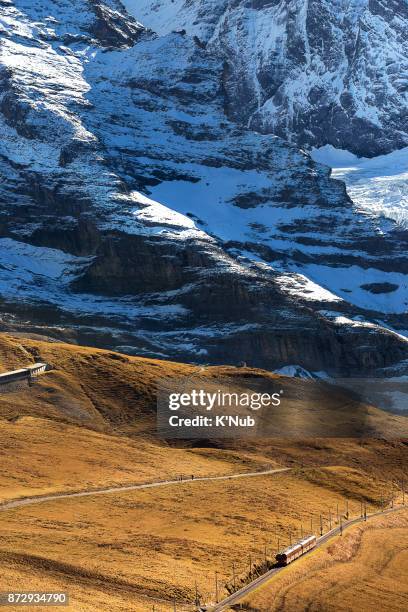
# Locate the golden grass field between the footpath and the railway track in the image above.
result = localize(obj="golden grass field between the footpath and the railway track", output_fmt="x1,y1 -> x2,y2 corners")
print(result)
0,468 -> 407,612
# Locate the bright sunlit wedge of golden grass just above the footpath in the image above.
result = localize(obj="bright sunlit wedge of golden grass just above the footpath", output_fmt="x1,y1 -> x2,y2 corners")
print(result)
0,417 -> 263,502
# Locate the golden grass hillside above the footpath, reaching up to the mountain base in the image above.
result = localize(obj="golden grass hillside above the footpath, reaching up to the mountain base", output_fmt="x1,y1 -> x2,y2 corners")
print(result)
0,334 -> 406,500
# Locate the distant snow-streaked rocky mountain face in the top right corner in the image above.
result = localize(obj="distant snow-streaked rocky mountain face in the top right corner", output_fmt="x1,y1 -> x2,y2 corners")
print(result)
124,0 -> 408,156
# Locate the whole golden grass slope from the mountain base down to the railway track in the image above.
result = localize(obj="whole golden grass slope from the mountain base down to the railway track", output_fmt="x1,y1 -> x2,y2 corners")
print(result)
0,335 -> 408,612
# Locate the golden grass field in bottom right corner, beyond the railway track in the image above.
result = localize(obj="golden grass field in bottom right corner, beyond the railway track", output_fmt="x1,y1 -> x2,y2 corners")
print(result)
242,509 -> 408,612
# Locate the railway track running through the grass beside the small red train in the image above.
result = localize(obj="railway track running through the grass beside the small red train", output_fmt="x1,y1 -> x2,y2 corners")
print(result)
209,506 -> 407,612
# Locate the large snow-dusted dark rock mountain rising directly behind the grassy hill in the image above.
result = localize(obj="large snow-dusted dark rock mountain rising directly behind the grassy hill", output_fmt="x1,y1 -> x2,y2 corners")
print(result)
0,0 -> 408,375
